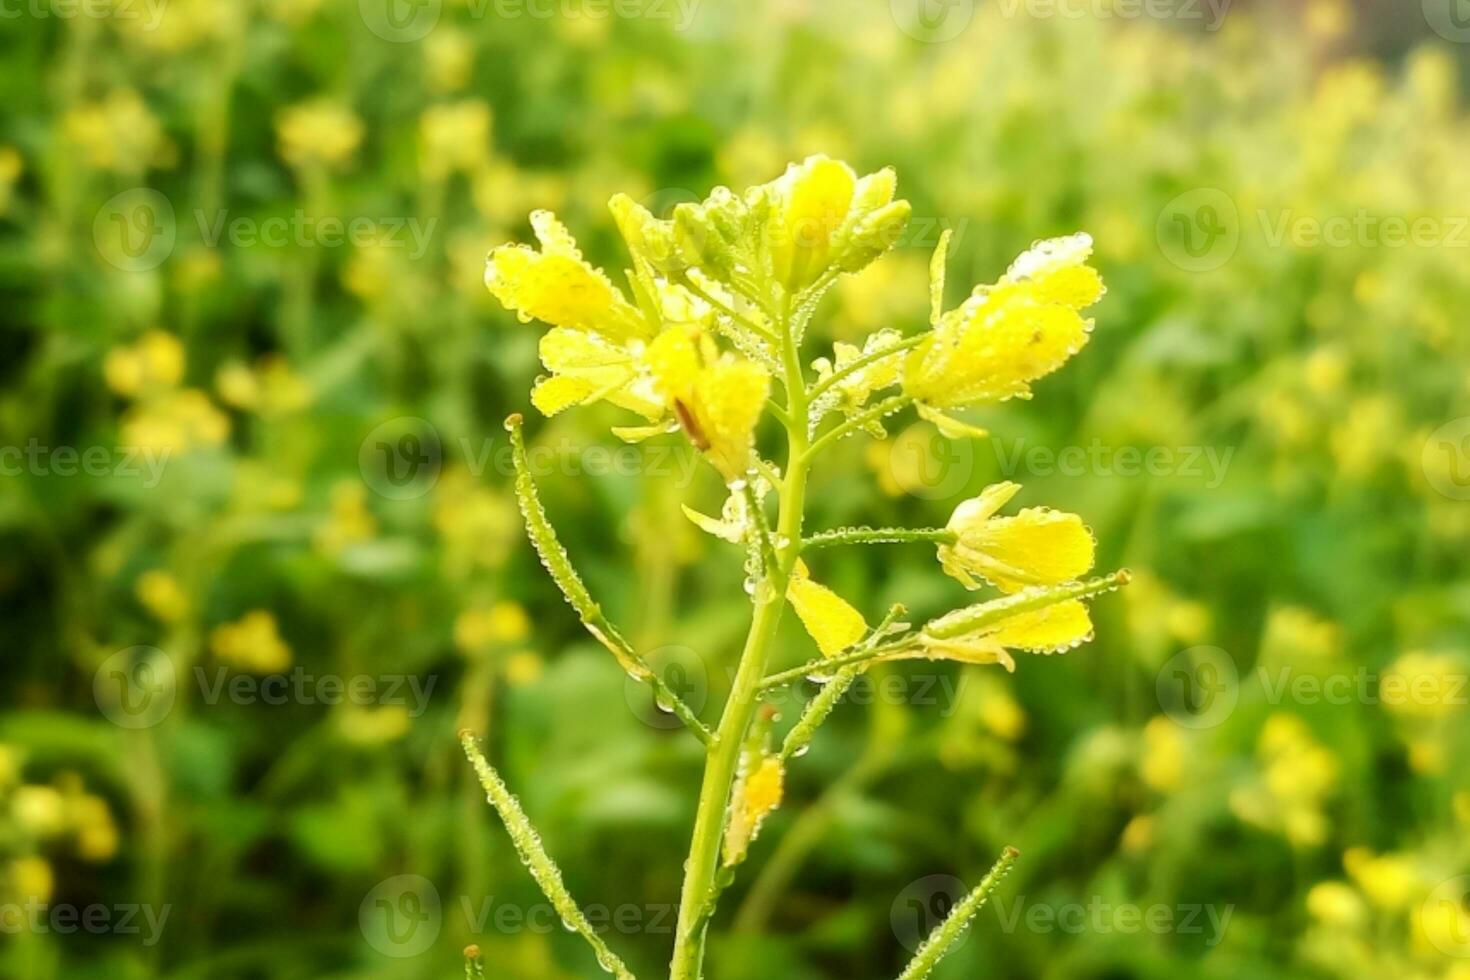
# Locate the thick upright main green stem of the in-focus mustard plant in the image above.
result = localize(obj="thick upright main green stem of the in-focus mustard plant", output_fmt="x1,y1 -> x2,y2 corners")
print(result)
669,296 -> 810,980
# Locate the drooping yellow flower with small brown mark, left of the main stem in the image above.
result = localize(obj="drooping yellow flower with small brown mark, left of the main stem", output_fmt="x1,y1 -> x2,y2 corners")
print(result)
648,326 -> 770,480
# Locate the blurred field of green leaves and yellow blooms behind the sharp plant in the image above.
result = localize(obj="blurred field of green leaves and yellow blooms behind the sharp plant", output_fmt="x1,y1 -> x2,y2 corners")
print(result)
0,0 -> 1470,980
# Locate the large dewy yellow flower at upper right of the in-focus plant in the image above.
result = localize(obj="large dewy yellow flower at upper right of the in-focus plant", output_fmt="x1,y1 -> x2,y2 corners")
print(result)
904,234 -> 1104,414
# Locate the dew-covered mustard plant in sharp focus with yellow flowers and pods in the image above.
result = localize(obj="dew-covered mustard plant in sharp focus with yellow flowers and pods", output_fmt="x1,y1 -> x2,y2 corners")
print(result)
460,156 -> 1127,980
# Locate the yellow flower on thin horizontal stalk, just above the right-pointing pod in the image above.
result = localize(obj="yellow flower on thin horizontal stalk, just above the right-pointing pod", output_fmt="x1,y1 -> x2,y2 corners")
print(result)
939,483 -> 1097,592
